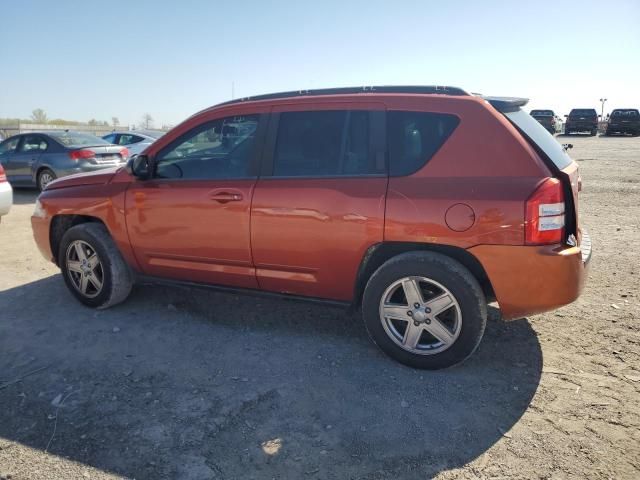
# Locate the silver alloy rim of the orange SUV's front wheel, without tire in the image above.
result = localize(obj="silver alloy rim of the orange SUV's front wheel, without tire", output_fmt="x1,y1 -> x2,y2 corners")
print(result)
66,240 -> 104,298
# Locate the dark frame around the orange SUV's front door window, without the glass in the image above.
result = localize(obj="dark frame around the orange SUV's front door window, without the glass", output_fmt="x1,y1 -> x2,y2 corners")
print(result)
149,113 -> 269,182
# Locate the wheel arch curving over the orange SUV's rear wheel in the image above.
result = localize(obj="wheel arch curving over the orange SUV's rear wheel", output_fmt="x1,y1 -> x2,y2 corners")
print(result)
352,242 -> 496,308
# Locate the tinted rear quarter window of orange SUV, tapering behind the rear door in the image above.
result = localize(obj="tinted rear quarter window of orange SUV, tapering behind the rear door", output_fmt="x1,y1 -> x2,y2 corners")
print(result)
387,111 -> 460,176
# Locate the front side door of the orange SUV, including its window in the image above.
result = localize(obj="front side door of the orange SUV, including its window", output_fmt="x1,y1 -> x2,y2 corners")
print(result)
125,114 -> 268,288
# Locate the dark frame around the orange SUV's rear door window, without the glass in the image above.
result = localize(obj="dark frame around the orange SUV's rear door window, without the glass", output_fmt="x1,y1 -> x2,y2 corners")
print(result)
260,109 -> 389,180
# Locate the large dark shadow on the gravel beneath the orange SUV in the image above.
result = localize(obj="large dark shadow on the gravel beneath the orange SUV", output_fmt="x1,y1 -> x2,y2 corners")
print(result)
0,275 -> 542,479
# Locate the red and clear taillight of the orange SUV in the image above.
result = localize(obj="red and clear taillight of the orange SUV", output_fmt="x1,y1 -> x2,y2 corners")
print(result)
524,178 -> 564,245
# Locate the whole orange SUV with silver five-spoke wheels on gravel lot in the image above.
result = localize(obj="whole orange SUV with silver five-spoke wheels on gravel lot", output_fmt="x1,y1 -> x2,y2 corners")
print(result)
32,87 -> 591,369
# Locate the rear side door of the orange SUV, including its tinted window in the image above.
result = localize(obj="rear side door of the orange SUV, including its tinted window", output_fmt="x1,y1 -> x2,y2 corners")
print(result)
251,102 -> 388,301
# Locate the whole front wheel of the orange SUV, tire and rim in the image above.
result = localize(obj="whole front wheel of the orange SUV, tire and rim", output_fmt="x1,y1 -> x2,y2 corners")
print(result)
58,222 -> 133,309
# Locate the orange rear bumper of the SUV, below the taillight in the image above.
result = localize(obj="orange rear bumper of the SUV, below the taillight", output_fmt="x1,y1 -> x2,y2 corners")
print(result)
469,232 -> 591,320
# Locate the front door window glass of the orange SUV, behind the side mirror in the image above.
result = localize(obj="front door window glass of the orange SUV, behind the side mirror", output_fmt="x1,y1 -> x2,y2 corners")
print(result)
155,115 -> 259,180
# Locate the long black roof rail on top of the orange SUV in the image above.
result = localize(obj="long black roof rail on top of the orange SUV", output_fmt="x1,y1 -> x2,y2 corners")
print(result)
216,85 -> 469,107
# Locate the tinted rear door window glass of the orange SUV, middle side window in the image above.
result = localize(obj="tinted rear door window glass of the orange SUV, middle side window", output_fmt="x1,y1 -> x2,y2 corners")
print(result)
273,110 -> 376,177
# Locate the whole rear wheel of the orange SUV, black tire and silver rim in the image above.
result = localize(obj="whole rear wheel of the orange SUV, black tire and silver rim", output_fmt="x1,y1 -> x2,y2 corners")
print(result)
362,252 -> 487,370
